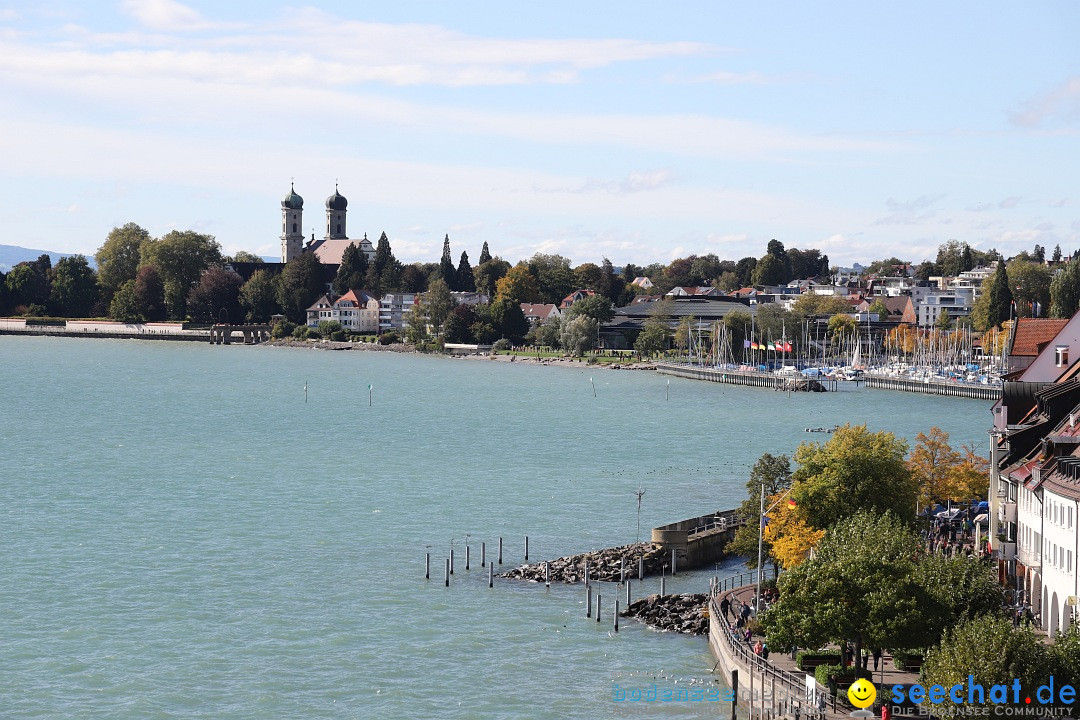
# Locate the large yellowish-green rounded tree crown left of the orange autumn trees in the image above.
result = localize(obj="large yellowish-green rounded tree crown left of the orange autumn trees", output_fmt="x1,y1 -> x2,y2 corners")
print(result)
792,424 -> 917,529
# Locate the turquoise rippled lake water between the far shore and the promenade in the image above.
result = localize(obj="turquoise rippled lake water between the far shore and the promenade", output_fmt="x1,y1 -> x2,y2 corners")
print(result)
0,336 -> 990,719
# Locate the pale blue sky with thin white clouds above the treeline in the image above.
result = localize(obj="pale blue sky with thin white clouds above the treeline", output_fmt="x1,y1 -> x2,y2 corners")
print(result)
0,0 -> 1080,266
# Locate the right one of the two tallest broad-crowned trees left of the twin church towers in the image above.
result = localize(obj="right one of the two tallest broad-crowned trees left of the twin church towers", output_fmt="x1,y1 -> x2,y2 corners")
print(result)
139,230 -> 222,320
